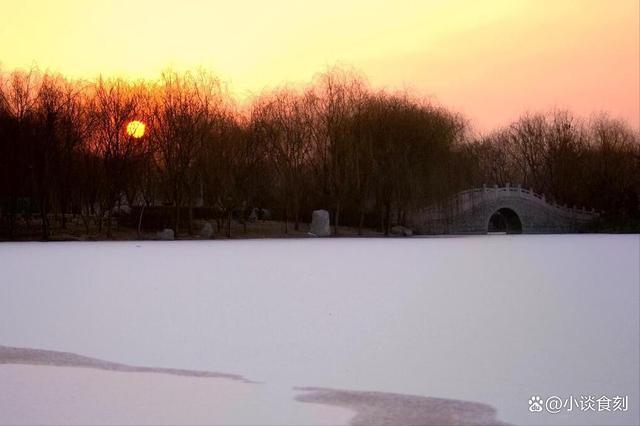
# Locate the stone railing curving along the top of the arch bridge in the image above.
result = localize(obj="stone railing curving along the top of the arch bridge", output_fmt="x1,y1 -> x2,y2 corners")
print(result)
422,184 -> 600,220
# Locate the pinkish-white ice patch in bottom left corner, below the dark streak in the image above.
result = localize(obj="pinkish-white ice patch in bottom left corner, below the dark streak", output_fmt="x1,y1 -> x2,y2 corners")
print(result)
0,365 -> 353,426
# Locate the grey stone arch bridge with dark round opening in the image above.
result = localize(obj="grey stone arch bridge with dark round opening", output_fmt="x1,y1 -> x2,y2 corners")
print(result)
410,184 -> 599,234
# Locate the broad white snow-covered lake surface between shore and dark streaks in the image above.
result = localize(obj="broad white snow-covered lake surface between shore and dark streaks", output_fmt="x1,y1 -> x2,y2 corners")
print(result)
0,235 -> 640,424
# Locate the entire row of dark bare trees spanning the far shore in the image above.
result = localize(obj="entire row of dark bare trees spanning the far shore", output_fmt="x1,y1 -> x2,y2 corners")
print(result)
0,68 -> 640,239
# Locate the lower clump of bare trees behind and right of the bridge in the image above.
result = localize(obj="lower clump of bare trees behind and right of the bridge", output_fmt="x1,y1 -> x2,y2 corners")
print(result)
461,110 -> 640,226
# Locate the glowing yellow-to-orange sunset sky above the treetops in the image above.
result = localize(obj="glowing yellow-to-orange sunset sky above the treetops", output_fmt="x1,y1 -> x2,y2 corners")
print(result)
0,0 -> 640,130
